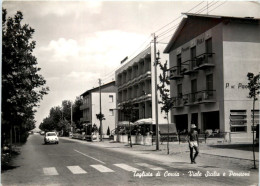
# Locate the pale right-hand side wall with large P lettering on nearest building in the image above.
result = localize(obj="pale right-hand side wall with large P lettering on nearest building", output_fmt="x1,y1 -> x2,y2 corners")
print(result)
223,41 -> 260,133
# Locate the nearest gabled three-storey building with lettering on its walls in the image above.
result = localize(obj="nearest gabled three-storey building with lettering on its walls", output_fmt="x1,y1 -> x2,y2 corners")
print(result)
164,14 -> 260,141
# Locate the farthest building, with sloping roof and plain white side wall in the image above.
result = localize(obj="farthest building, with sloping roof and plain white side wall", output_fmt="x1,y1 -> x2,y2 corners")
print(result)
80,81 -> 116,135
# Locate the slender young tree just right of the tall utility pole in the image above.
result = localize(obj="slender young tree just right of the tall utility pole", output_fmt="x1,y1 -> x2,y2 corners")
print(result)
157,52 -> 174,154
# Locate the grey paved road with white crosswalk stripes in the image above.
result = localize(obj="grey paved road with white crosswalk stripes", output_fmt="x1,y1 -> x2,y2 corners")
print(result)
2,134 -> 258,186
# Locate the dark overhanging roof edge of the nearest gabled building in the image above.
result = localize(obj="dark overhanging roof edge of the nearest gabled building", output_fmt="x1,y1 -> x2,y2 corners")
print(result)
164,13 -> 260,53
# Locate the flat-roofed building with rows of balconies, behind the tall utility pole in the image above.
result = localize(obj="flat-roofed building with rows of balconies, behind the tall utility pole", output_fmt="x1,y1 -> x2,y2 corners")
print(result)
115,44 -> 168,123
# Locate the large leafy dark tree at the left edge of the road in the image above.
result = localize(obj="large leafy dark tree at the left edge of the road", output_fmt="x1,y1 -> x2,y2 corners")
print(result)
2,9 -> 49,143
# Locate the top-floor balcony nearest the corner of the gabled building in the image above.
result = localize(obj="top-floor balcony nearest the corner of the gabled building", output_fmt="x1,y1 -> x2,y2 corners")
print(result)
194,53 -> 215,70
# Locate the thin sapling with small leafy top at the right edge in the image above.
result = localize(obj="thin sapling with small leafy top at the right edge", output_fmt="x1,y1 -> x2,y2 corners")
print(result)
247,72 -> 260,169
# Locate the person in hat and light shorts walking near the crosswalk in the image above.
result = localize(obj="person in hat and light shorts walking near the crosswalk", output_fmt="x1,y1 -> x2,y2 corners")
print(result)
187,124 -> 199,164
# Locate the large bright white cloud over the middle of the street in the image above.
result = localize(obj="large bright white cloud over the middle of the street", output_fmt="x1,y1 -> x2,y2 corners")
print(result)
37,30 -> 146,70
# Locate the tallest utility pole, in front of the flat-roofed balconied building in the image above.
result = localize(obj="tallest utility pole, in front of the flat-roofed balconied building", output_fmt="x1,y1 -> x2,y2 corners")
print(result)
153,33 -> 159,150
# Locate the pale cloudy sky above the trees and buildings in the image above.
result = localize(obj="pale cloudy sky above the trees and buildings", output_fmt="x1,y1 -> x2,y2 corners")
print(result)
2,0 -> 260,129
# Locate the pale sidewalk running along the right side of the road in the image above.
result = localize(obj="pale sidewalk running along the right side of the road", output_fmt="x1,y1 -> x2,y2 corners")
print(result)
62,137 -> 259,163
